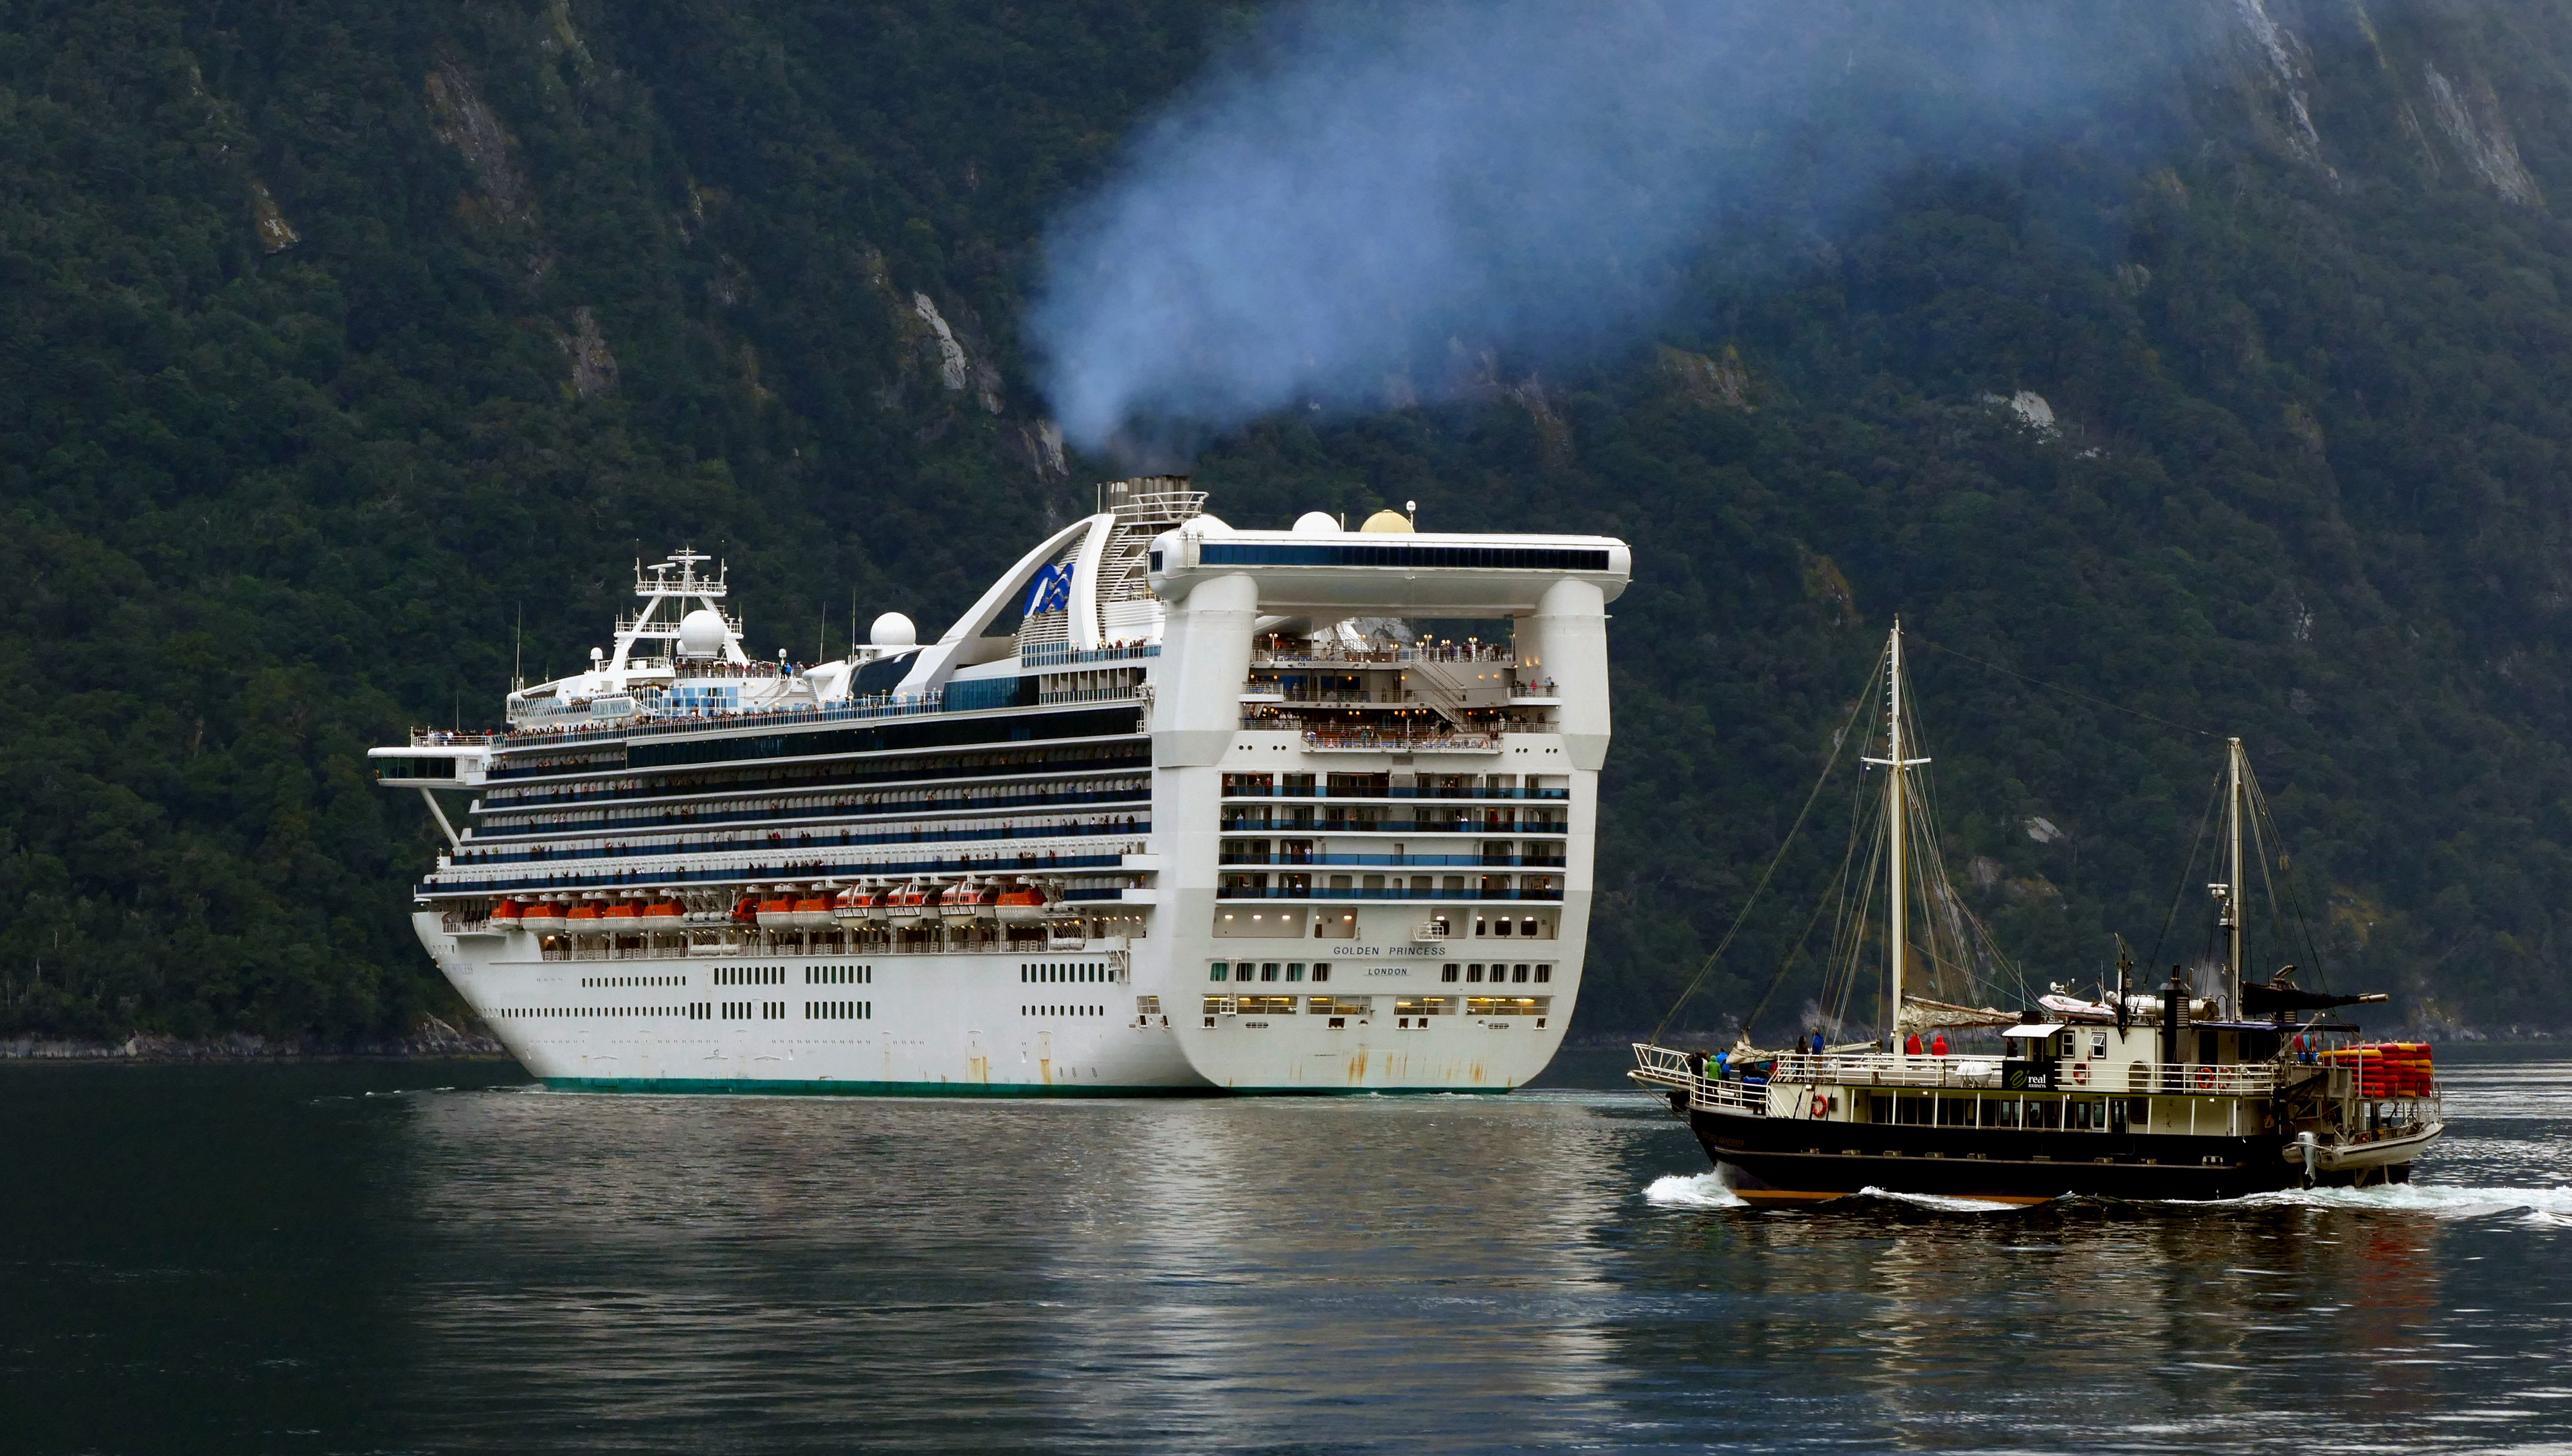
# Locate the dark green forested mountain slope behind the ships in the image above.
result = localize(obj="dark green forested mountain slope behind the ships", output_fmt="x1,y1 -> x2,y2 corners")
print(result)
0,0 -> 2572,1037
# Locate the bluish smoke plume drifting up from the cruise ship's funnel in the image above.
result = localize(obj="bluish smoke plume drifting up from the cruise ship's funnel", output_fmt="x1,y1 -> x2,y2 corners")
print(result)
1031,0 -> 2140,450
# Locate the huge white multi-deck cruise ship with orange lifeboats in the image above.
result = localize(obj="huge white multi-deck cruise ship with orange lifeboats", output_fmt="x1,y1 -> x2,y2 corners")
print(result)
370,476 -> 1631,1096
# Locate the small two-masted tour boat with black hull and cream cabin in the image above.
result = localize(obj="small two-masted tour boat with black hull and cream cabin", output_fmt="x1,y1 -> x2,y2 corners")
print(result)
1628,625 -> 2446,1201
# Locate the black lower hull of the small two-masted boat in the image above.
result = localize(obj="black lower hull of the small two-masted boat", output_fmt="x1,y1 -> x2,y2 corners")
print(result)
1687,1109 -> 2410,1204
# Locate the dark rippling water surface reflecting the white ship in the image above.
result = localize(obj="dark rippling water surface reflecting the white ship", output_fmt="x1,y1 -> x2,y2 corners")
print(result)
0,1057 -> 2572,1453
